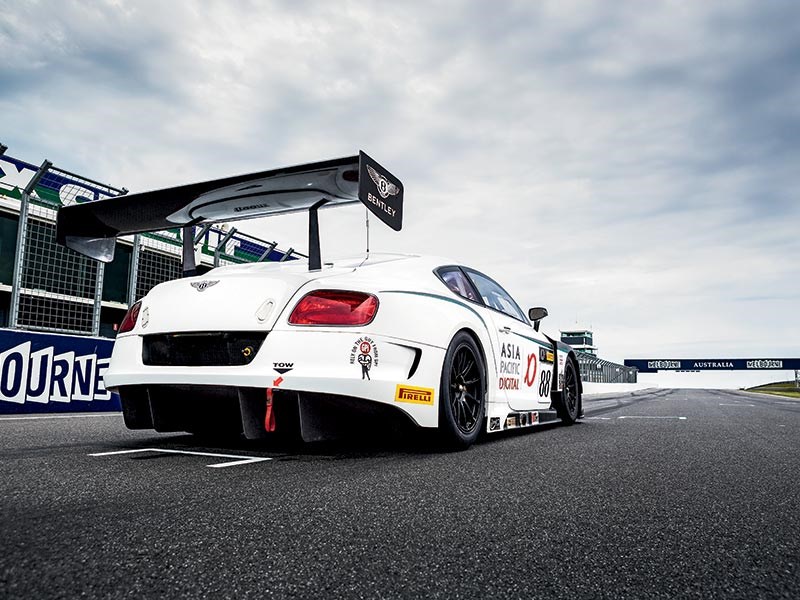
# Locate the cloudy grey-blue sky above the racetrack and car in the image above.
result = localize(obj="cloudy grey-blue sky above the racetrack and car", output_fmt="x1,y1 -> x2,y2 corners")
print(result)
0,0 -> 800,384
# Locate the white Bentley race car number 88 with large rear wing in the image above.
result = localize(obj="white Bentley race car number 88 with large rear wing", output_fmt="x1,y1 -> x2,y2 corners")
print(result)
59,153 -> 582,447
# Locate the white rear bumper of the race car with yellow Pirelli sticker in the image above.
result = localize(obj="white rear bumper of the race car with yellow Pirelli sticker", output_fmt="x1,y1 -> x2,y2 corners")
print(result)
105,329 -> 445,427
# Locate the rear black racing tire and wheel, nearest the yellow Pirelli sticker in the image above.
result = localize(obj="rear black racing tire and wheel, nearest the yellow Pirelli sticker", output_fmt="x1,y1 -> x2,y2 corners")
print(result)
439,331 -> 486,449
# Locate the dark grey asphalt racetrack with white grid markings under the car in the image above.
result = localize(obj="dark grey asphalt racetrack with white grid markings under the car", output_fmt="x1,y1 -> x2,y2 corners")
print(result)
0,390 -> 800,599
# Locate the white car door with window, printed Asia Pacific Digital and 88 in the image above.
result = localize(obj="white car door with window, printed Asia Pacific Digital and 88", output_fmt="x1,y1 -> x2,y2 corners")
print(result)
464,267 -> 553,411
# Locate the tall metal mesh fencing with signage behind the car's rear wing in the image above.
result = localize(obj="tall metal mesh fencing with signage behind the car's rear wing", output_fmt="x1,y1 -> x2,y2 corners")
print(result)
0,145 -> 298,337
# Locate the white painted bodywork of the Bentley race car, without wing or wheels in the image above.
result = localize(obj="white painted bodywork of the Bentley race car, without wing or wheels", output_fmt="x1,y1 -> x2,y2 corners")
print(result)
105,254 -> 580,430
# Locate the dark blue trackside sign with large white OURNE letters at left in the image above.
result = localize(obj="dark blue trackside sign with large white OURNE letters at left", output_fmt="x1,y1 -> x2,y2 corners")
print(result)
0,329 -> 120,413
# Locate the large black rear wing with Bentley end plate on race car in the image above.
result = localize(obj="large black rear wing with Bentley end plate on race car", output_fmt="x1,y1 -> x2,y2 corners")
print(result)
57,152 -> 403,270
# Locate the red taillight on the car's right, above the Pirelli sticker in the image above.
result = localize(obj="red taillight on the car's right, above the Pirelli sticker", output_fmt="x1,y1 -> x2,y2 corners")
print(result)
289,290 -> 378,325
